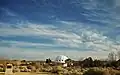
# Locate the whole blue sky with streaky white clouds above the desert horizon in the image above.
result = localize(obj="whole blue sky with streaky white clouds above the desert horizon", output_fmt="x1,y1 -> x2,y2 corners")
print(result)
0,0 -> 120,60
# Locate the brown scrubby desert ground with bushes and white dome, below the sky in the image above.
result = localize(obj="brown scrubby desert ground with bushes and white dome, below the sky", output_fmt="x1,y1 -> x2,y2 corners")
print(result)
0,55 -> 120,75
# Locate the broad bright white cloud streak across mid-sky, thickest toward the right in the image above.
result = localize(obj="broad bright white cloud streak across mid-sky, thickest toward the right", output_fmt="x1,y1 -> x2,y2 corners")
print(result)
0,22 -> 120,51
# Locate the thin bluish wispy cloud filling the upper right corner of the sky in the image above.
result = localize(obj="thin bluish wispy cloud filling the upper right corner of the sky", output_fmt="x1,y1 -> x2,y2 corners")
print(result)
72,0 -> 120,27
